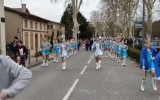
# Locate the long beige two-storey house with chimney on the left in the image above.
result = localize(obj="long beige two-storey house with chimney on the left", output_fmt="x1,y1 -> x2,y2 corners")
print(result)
5,4 -> 65,55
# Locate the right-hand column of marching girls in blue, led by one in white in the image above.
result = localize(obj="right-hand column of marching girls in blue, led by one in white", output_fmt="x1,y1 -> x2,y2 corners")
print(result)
92,37 -> 128,69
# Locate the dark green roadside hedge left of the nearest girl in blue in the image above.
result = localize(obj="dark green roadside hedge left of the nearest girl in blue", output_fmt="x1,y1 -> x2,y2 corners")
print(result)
128,47 -> 140,62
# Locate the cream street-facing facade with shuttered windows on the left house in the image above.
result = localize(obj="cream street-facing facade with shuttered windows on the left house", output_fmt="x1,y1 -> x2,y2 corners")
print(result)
23,19 -> 47,56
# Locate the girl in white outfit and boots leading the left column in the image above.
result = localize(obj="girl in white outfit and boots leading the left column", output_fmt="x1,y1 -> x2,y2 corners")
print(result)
60,39 -> 67,70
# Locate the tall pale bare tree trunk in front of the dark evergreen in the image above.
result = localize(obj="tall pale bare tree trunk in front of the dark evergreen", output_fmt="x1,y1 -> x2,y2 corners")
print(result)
51,0 -> 83,39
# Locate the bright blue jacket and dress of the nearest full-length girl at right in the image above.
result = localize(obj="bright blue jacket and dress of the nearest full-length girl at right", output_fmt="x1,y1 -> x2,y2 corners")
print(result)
140,48 -> 156,71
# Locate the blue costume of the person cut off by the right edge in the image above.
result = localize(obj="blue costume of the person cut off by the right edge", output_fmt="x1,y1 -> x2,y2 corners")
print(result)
155,53 -> 160,80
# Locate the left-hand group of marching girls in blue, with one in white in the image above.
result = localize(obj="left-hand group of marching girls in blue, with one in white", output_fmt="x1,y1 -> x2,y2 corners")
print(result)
42,38 -> 78,70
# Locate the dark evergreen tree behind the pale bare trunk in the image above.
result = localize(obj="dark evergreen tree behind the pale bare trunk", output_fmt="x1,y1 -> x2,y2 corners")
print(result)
61,4 -> 94,39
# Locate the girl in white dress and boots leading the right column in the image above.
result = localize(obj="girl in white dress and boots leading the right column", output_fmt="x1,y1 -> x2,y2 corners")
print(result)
92,37 -> 103,70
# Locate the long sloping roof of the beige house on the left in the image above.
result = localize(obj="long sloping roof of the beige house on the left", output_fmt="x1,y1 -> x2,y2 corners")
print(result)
4,6 -> 65,26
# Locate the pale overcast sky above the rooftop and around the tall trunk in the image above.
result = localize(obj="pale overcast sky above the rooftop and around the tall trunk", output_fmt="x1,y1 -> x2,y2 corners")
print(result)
4,0 -> 100,22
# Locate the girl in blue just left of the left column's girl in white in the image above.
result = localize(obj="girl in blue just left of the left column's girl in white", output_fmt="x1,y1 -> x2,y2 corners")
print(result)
53,39 -> 59,63
